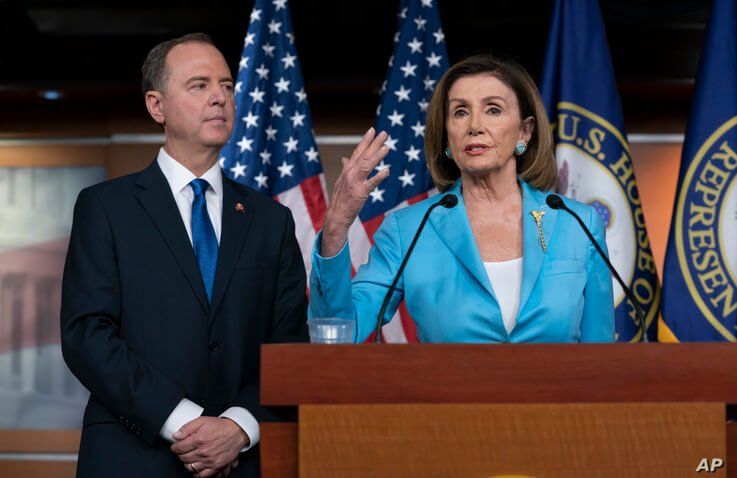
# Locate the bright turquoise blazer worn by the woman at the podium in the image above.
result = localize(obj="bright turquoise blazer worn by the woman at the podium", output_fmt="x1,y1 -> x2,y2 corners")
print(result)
309,179 -> 614,343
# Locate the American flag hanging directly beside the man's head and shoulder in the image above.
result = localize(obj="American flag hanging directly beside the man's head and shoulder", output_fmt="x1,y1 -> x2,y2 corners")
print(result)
220,0 -> 327,275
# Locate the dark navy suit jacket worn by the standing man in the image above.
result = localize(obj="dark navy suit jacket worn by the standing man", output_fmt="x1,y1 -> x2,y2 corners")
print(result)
61,161 -> 307,477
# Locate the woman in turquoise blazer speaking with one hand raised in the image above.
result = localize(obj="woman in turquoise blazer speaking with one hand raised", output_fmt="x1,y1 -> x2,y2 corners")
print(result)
310,55 -> 614,342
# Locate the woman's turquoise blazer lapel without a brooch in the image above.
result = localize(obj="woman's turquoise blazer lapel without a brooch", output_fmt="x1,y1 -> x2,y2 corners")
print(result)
430,181 -> 496,300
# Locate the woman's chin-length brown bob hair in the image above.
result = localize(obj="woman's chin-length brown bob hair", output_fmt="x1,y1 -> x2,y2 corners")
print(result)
425,55 -> 558,192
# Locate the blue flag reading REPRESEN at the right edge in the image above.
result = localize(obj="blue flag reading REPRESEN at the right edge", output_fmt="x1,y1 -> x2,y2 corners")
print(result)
658,0 -> 737,342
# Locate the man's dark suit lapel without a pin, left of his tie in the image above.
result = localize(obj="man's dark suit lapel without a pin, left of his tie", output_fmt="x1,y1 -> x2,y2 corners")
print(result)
136,161 -> 210,314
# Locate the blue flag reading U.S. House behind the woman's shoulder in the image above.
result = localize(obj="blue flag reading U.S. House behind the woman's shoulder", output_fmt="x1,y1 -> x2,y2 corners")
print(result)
541,0 -> 660,342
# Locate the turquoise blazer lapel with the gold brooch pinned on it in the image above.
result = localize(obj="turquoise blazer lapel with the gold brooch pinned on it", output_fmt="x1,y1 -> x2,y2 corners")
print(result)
519,179 -> 558,315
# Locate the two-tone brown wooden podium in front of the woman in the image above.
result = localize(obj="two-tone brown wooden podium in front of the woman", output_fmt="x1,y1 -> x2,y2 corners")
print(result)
260,343 -> 737,478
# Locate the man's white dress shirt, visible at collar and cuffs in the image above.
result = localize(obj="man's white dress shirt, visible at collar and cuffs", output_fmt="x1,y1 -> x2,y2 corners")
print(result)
156,148 -> 261,451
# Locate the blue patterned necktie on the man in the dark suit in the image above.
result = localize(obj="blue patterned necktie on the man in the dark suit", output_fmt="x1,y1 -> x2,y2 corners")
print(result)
189,179 -> 218,301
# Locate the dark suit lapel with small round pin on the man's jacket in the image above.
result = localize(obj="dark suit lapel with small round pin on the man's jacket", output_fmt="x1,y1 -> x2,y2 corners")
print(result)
210,176 -> 255,320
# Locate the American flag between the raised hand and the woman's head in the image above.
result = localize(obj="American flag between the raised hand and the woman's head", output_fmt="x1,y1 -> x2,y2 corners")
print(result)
348,0 -> 448,342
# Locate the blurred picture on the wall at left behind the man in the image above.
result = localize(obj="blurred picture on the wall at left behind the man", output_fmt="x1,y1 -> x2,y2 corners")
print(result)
0,166 -> 105,429
